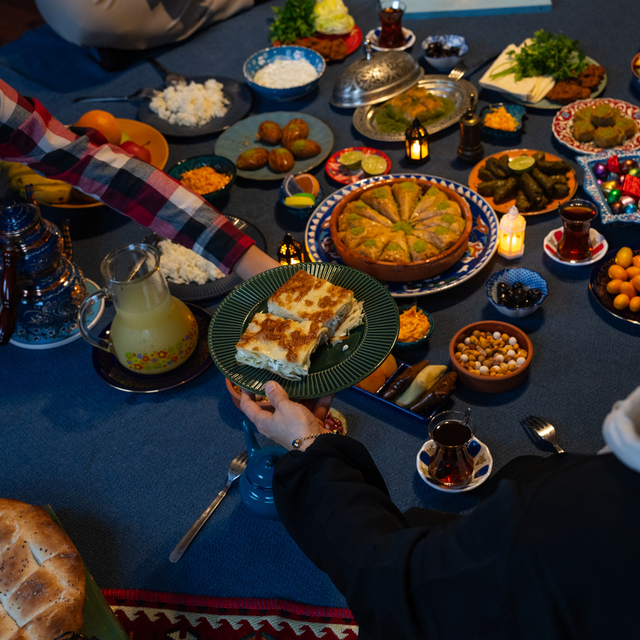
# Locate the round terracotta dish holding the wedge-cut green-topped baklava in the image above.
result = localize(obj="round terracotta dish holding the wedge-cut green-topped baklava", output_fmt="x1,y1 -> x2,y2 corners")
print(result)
330,178 -> 473,282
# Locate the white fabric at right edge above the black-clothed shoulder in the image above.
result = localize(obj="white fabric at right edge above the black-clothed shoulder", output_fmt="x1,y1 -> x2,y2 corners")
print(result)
602,387 -> 640,471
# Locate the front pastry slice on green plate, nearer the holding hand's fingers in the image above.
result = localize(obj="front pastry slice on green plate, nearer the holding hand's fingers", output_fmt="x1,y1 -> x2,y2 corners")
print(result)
236,313 -> 328,380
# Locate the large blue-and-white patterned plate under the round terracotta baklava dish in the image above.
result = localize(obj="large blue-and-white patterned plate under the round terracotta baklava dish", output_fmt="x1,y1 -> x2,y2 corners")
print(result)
304,173 -> 498,298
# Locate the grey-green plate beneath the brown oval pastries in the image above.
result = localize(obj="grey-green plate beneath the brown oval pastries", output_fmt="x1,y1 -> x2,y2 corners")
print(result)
215,111 -> 333,180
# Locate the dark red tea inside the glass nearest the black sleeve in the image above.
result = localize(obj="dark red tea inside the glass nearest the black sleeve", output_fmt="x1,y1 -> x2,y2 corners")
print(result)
429,420 -> 473,485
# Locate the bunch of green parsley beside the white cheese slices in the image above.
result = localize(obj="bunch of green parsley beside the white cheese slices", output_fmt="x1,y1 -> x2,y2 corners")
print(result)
491,29 -> 587,81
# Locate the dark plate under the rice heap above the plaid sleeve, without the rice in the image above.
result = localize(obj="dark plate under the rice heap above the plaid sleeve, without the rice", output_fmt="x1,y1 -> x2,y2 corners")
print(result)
138,76 -> 252,139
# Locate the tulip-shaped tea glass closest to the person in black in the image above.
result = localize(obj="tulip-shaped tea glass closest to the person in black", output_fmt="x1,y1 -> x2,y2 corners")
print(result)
429,411 -> 476,487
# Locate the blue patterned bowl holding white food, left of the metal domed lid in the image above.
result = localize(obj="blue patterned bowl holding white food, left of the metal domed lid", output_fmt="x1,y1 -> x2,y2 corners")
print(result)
242,45 -> 327,101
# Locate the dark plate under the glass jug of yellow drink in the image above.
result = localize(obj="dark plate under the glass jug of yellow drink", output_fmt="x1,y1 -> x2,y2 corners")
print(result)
92,303 -> 213,393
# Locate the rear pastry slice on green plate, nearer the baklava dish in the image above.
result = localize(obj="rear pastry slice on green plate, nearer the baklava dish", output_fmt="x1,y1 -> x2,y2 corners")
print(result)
268,269 -> 362,338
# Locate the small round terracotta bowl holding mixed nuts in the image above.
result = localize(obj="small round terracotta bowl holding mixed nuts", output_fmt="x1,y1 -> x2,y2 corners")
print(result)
449,320 -> 533,393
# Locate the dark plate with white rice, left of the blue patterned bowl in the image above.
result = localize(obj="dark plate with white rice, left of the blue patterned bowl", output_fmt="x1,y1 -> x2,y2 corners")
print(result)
138,76 -> 252,138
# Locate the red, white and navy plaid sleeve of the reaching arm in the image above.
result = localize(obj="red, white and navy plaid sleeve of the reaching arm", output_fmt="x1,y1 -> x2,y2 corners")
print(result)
0,80 -> 254,273
